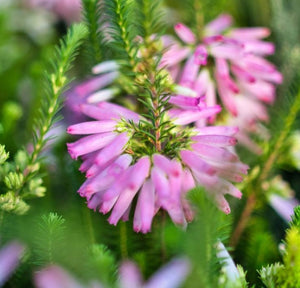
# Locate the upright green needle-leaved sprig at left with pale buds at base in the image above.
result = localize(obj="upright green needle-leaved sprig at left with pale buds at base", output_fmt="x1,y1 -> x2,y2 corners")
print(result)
0,24 -> 87,214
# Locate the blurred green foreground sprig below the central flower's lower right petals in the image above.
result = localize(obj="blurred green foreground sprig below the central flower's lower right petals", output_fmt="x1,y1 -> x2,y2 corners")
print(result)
184,188 -> 230,288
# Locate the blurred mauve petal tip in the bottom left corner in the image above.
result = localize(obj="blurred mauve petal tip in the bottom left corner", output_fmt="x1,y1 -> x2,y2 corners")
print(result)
0,242 -> 25,287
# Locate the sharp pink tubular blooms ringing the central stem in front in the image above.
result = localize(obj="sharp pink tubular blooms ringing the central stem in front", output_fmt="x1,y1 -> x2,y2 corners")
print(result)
67,96 -> 248,233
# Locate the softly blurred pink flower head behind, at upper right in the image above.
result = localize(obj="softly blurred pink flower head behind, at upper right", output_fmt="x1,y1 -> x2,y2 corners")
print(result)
161,14 -> 282,152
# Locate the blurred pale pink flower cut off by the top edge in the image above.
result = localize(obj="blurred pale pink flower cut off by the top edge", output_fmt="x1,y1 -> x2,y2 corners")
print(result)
24,0 -> 81,24
